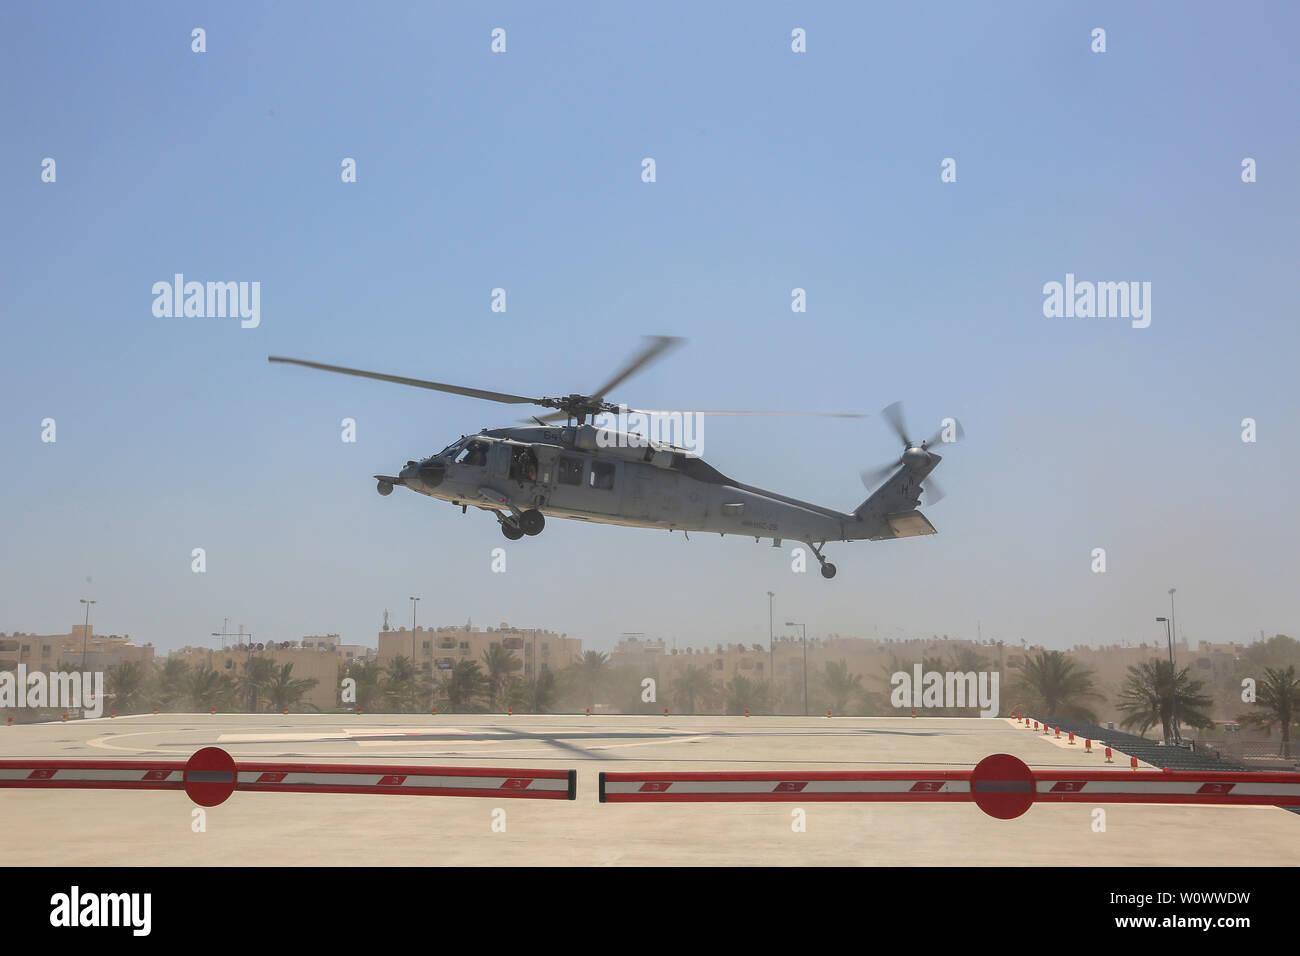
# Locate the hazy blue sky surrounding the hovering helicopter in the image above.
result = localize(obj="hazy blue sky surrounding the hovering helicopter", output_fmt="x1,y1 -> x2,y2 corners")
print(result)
0,1 -> 1300,658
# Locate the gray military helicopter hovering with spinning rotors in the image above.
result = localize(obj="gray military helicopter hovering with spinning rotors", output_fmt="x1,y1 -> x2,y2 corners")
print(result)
268,336 -> 962,578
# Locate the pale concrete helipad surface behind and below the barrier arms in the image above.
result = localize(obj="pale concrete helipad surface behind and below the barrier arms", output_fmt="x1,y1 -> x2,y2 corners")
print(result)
0,714 -> 1300,866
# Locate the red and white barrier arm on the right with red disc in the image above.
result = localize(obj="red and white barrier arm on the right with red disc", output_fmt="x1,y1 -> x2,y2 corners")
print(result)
599,753 -> 1300,819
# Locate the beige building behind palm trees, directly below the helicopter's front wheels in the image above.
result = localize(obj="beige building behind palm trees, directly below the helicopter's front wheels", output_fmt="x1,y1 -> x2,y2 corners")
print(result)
378,623 -> 582,679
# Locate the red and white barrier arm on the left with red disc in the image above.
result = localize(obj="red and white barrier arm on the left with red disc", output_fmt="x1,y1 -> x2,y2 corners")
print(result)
0,747 -> 577,806
